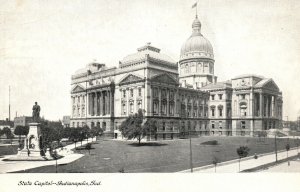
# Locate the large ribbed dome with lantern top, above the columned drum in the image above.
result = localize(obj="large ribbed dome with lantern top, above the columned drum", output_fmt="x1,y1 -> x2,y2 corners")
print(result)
180,17 -> 214,59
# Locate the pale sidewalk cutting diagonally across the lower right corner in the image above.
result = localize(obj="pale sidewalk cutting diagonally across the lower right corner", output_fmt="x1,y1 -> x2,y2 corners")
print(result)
180,148 -> 300,173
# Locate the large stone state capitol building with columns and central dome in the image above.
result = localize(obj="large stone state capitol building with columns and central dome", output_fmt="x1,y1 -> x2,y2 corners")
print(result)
70,16 -> 282,140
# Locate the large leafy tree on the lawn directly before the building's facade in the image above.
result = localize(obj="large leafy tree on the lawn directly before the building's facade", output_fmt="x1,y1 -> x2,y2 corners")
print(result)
119,109 -> 156,145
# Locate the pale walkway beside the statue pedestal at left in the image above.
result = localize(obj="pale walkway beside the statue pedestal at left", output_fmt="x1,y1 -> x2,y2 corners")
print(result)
0,138 -> 96,173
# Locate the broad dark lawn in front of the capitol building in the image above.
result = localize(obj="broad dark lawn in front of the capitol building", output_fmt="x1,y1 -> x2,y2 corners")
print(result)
14,137 -> 296,173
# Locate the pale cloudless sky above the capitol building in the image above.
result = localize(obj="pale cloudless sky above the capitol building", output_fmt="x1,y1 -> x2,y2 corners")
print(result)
0,0 -> 300,120
